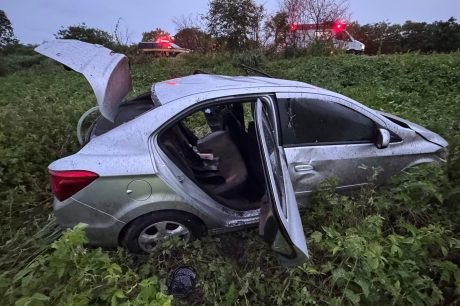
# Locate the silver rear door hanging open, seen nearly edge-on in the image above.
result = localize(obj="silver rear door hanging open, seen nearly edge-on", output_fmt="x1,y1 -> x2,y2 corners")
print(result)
255,98 -> 308,266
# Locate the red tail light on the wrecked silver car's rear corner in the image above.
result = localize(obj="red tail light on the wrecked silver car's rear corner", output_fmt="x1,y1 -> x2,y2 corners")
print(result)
49,170 -> 99,201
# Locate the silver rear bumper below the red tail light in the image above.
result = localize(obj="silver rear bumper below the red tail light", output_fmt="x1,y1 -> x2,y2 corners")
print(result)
53,198 -> 125,247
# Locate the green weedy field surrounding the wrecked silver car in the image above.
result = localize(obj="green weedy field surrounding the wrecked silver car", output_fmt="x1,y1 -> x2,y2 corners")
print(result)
0,53 -> 460,305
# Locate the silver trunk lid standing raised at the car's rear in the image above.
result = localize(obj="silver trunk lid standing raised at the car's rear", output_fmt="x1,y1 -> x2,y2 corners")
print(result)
35,39 -> 131,122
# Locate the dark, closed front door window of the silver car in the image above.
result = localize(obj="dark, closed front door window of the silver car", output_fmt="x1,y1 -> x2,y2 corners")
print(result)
278,98 -> 375,145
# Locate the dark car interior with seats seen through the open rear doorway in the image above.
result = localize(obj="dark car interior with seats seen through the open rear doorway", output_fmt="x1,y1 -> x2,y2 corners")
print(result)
159,101 -> 266,211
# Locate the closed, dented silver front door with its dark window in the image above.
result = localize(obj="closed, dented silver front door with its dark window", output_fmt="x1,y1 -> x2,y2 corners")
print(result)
277,94 -> 400,202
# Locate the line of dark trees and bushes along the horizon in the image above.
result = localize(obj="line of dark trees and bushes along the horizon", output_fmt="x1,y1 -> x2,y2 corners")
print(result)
0,0 -> 460,54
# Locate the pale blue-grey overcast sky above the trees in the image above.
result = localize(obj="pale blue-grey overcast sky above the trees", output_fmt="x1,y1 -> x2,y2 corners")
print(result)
0,0 -> 460,43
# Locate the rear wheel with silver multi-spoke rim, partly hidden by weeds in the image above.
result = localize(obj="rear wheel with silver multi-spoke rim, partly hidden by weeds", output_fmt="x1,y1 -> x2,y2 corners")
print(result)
121,211 -> 205,253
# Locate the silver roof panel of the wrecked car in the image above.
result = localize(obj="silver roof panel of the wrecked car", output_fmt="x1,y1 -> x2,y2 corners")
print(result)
152,74 -> 319,105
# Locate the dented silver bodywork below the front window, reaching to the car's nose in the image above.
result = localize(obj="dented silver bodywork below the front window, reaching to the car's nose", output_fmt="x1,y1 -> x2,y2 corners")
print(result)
285,140 -> 445,204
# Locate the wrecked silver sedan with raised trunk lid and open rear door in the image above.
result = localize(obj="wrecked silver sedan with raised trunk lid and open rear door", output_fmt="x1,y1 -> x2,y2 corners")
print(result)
36,40 -> 447,265
